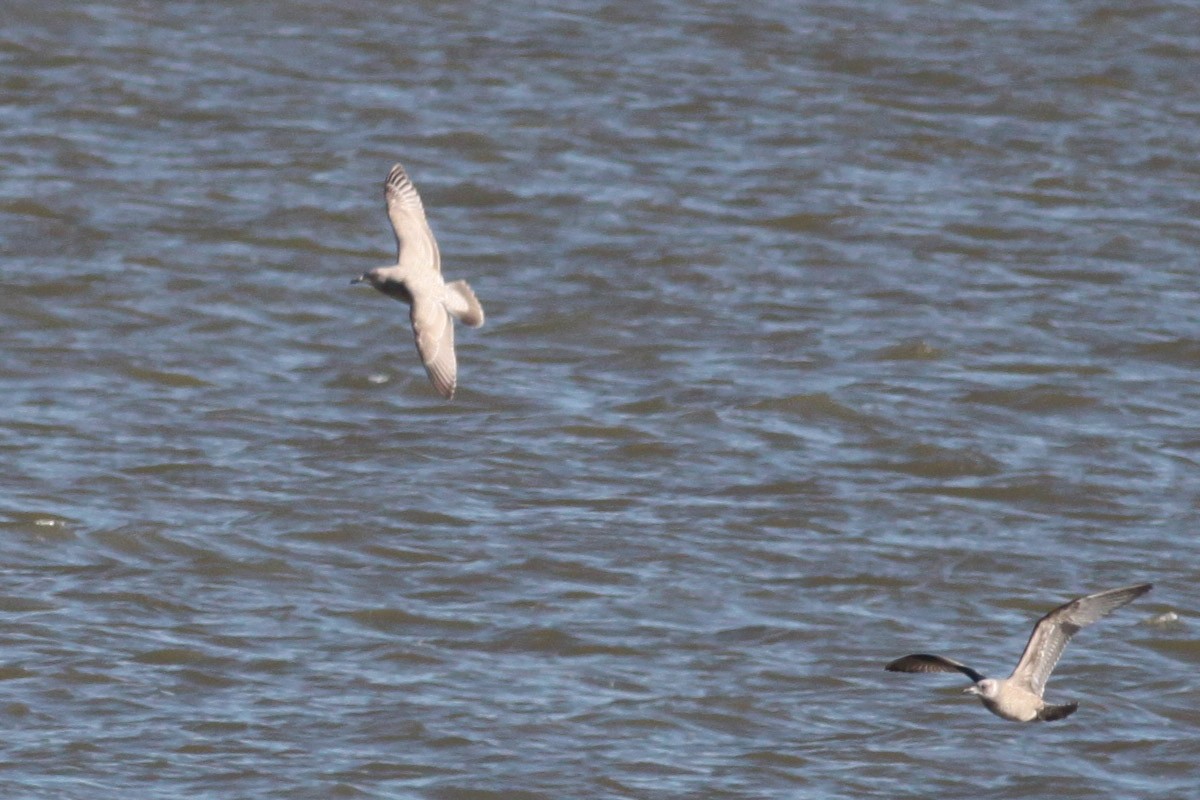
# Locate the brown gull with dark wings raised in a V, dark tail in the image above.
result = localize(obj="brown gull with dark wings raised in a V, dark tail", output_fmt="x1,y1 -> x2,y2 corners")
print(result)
884,583 -> 1153,722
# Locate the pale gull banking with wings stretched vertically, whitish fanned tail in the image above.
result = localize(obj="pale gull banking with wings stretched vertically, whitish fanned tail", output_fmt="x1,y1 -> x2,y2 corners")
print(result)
350,164 -> 484,399
